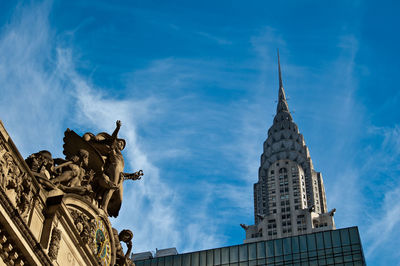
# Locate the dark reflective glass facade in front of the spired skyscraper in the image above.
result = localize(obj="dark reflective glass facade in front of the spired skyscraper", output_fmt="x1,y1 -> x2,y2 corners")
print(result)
135,227 -> 366,266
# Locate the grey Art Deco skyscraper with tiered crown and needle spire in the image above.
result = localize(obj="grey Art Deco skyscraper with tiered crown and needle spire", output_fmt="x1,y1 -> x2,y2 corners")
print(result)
241,53 -> 335,243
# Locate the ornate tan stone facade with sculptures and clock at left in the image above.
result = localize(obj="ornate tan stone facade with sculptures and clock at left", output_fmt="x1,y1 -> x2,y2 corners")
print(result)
0,121 -> 143,266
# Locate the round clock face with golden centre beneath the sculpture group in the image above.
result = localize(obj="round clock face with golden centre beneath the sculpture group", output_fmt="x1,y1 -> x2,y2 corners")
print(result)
94,219 -> 111,266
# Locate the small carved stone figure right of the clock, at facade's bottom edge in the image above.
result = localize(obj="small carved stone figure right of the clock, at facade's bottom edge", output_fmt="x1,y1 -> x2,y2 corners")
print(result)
113,228 -> 134,266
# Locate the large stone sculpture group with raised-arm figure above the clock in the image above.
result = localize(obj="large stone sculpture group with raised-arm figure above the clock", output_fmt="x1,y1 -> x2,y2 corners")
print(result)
25,120 -> 143,217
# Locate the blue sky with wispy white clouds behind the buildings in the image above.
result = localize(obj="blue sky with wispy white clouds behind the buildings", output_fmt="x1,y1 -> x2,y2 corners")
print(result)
0,1 -> 400,265
